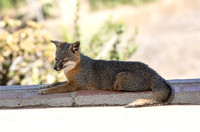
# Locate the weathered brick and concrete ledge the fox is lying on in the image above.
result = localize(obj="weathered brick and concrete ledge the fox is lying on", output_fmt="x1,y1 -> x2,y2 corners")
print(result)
0,79 -> 200,108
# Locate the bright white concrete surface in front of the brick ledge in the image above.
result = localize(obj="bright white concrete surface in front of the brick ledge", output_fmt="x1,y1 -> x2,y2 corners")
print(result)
0,105 -> 200,132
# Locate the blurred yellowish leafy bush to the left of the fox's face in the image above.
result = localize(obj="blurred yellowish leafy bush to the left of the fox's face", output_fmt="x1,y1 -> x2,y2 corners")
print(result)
0,18 -> 63,85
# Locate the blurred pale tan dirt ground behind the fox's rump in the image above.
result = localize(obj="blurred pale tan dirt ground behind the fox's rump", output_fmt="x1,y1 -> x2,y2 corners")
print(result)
131,0 -> 200,79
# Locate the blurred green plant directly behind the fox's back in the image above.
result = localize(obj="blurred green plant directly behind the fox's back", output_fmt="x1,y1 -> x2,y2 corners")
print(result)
79,18 -> 137,60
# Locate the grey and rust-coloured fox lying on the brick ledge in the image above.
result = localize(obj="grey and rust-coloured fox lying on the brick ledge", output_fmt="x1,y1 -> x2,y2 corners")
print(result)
39,41 -> 172,107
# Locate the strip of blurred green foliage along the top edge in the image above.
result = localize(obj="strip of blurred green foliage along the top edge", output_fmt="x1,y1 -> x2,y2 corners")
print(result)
88,0 -> 156,11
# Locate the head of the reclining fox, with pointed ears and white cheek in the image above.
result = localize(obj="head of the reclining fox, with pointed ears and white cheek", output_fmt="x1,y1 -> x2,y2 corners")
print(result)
51,41 -> 80,71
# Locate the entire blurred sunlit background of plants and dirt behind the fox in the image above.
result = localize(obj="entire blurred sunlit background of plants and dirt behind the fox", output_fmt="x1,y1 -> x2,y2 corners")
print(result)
0,0 -> 200,85
